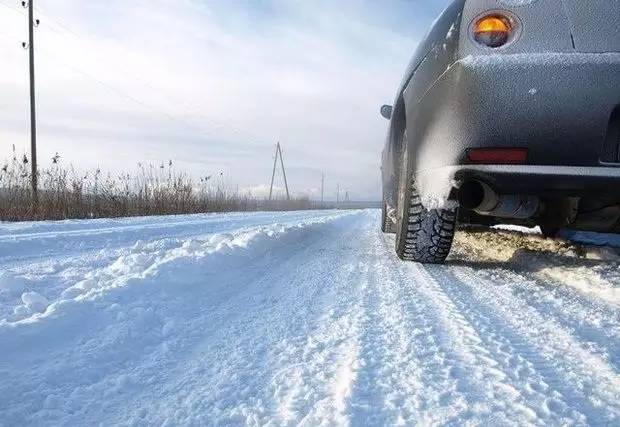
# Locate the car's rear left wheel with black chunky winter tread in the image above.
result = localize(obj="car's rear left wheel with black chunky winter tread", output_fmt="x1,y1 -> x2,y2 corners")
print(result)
396,135 -> 457,264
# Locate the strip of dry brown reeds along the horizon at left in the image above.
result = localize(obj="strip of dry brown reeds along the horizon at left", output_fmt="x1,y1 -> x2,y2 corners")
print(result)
0,150 -> 314,221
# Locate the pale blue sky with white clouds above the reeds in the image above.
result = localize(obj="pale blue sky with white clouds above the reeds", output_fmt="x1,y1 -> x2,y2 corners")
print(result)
0,0 -> 447,200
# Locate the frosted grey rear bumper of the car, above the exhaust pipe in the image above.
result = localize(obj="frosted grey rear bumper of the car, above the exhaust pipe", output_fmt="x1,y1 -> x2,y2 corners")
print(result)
407,53 -> 620,172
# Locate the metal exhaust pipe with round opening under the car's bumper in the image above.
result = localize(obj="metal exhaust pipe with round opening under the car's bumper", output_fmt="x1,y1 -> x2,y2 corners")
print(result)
459,181 -> 540,219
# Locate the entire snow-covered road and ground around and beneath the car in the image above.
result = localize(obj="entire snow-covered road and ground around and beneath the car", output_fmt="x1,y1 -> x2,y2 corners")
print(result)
0,211 -> 620,426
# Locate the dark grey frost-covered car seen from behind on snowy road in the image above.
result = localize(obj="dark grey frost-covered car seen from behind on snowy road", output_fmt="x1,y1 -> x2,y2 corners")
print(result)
381,0 -> 620,263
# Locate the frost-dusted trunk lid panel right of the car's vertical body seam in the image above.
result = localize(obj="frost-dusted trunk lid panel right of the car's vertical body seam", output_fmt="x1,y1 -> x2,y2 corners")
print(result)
563,0 -> 620,53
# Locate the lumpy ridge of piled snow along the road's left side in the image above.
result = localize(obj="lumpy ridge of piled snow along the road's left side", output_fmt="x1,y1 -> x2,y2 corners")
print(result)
0,212 -> 352,329
